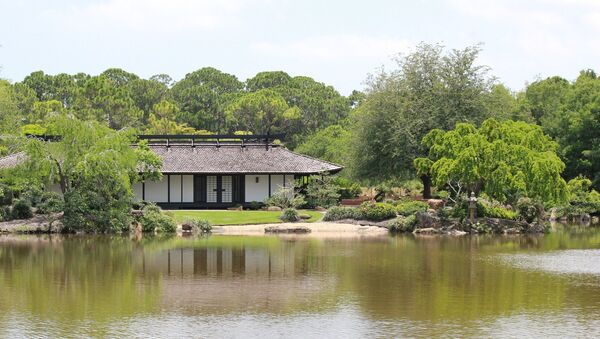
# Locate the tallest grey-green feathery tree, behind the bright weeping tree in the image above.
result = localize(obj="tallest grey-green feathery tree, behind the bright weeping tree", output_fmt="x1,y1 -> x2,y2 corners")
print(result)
352,44 -> 494,180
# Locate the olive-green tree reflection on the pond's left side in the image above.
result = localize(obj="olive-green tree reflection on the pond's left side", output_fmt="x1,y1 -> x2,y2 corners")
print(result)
0,236 -> 160,327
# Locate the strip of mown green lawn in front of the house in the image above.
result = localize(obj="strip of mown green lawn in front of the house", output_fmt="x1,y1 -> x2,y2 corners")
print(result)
169,210 -> 323,225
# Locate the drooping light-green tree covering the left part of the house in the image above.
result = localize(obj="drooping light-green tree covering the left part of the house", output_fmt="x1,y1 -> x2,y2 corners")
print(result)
22,115 -> 161,232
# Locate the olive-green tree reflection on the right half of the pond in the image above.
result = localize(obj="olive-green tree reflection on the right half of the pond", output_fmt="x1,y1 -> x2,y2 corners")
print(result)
338,235 -> 597,321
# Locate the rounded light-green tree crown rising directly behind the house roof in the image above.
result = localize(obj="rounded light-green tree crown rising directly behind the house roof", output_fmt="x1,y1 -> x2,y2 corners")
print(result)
226,89 -> 300,134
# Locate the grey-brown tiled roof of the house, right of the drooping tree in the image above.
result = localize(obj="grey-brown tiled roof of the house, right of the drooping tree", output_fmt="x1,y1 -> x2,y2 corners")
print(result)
150,144 -> 342,174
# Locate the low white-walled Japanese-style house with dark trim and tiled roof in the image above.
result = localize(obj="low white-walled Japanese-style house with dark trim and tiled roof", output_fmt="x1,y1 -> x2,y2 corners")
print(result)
0,135 -> 342,209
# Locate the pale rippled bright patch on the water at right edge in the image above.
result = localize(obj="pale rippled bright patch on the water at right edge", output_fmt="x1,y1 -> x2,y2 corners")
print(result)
500,250 -> 600,278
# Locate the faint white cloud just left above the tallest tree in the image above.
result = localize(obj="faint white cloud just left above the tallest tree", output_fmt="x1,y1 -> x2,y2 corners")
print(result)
252,34 -> 413,62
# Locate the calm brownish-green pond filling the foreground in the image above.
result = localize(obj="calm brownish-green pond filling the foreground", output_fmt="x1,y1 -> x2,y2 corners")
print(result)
0,226 -> 600,338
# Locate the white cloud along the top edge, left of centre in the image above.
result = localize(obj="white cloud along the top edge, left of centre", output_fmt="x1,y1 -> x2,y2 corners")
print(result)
56,0 -> 263,32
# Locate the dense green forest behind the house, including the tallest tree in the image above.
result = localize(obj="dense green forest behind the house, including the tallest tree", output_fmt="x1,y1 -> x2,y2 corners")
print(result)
0,44 -> 600,189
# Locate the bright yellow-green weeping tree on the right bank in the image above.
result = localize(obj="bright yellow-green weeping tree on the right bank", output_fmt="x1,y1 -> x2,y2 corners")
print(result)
414,119 -> 567,204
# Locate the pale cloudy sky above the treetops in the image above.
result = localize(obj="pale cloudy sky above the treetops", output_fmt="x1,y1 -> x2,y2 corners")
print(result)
0,0 -> 600,95
